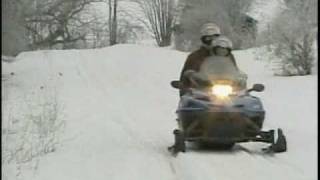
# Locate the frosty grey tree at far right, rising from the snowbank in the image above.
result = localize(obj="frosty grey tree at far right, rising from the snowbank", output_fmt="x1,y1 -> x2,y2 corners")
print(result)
268,0 -> 318,75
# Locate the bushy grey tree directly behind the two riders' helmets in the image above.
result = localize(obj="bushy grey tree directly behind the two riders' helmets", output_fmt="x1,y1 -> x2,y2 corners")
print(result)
174,0 -> 256,51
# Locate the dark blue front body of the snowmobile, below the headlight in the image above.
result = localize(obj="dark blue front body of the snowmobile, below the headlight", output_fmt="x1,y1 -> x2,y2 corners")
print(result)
176,89 -> 265,142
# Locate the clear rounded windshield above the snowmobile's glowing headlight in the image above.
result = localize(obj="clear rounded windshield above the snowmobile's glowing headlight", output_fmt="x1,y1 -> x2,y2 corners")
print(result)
198,56 -> 240,81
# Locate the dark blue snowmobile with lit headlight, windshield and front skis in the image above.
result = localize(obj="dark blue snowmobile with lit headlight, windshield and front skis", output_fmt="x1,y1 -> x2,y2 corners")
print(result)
168,57 -> 287,154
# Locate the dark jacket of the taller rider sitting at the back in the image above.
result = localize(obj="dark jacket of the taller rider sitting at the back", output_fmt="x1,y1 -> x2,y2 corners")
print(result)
180,46 -> 237,95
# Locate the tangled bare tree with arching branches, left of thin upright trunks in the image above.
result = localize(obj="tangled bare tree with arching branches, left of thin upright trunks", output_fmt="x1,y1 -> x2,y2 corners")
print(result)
26,0 -> 101,49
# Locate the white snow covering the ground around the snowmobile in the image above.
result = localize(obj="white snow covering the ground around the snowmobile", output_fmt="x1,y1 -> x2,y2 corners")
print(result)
2,45 -> 317,180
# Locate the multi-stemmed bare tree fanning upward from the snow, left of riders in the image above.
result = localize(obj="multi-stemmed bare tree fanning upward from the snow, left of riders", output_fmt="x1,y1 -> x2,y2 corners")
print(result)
134,0 -> 175,47
